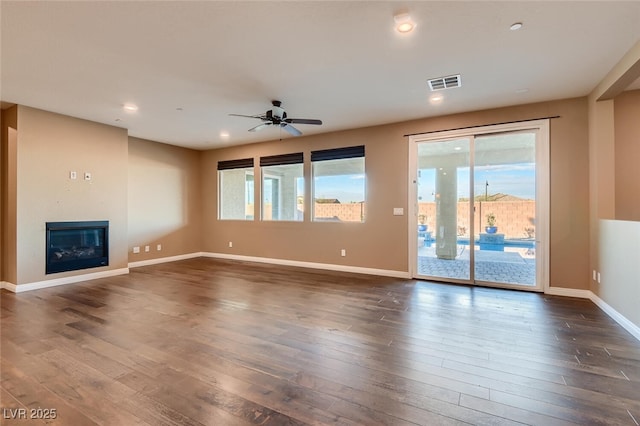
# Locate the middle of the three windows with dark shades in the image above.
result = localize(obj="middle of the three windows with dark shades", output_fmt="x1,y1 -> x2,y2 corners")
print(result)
260,152 -> 304,221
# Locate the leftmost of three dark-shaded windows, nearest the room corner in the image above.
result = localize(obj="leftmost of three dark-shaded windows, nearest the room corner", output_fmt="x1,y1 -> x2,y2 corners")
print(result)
218,158 -> 254,220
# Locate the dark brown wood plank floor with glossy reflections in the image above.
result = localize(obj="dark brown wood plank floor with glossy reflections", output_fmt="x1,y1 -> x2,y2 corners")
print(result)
0,258 -> 640,426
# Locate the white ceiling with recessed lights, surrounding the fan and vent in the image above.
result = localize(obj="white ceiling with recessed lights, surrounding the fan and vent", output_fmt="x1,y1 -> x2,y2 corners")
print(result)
0,0 -> 640,149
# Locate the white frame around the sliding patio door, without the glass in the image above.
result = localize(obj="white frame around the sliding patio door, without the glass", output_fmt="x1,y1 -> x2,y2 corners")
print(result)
407,119 -> 550,291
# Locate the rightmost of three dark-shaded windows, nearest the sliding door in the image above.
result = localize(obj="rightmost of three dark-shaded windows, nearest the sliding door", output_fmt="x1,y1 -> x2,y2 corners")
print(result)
311,145 -> 366,222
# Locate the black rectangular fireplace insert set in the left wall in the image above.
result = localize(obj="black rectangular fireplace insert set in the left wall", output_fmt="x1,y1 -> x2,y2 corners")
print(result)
46,220 -> 109,274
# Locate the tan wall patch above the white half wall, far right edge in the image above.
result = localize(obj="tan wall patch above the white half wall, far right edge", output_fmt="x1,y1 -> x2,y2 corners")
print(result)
613,90 -> 640,221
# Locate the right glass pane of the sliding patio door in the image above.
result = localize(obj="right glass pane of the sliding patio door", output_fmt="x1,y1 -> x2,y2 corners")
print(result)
474,132 -> 536,286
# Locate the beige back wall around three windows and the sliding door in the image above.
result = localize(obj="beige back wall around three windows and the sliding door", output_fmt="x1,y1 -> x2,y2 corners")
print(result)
202,98 -> 589,289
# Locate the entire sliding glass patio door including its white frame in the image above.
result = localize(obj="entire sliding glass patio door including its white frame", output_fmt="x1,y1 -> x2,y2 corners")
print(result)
409,121 -> 548,290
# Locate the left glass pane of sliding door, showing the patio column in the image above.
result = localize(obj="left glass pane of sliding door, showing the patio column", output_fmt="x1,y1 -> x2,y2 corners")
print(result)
417,138 -> 471,280
